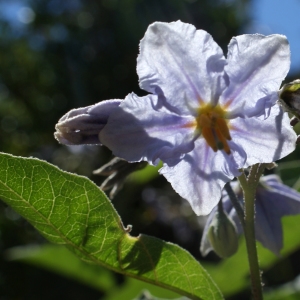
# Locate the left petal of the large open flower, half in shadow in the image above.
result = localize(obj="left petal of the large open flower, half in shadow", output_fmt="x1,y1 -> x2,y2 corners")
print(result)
100,94 -> 194,165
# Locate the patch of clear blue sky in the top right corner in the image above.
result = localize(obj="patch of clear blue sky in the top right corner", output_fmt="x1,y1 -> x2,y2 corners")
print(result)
247,0 -> 300,74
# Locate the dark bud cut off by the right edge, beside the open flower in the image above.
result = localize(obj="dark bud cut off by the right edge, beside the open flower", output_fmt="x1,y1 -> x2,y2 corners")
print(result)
279,79 -> 300,120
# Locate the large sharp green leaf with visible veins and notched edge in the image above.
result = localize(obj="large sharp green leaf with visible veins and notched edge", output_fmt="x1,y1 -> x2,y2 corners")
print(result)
0,154 -> 222,300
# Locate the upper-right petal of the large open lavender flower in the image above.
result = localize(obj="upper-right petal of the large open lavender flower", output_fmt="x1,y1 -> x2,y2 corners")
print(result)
220,34 -> 290,116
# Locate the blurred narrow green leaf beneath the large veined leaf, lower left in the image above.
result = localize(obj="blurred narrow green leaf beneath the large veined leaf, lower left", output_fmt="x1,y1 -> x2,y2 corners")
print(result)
6,244 -> 116,292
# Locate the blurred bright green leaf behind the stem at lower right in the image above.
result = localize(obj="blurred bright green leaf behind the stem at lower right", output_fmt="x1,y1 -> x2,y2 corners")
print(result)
203,215 -> 300,296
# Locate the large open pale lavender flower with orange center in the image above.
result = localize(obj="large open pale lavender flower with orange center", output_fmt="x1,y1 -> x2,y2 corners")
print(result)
55,21 -> 296,215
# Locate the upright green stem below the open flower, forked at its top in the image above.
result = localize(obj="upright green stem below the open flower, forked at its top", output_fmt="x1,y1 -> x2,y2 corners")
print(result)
238,164 -> 265,300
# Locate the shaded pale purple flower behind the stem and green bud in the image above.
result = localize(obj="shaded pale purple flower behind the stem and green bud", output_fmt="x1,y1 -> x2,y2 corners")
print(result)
200,175 -> 300,256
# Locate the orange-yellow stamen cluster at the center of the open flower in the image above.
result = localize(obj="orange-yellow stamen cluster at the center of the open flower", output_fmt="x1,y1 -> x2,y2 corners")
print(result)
196,104 -> 231,154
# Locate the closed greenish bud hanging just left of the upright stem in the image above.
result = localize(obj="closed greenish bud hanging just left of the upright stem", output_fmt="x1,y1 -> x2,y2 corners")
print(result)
208,211 -> 238,258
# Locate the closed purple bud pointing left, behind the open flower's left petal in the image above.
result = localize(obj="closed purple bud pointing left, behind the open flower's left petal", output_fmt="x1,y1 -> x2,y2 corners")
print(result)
54,100 -> 121,145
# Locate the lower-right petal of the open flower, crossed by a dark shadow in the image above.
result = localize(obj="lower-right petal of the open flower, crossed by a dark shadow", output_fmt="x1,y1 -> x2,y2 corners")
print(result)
230,105 -> 297,168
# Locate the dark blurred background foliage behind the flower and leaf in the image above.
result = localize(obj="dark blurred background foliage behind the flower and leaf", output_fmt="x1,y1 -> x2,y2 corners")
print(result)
0,0 -> 299,300
